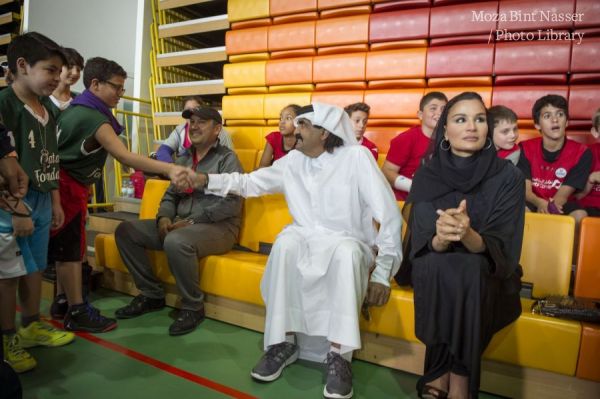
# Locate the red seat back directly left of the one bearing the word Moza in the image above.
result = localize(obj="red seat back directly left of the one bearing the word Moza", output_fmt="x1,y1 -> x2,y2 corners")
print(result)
369,8 -> 429,43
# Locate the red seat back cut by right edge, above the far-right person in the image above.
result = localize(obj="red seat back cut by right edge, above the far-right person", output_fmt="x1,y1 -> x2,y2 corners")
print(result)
569,82 -> 600,129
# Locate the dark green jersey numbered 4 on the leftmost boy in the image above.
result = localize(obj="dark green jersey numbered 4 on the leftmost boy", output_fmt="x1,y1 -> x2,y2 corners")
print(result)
0,87 -> 59,192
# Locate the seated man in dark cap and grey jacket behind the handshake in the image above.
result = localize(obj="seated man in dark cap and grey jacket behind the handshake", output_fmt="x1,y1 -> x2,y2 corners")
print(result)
115,107 -> 242,335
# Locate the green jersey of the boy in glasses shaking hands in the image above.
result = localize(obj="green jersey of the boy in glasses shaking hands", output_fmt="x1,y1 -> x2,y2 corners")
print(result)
58,105 -> 109,184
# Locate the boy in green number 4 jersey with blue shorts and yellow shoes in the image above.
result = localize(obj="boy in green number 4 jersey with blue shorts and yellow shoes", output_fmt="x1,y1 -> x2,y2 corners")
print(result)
0,32 -> 74,372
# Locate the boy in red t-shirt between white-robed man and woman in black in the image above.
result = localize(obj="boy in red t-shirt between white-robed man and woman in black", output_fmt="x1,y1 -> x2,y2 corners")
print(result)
381,91 -> 448,201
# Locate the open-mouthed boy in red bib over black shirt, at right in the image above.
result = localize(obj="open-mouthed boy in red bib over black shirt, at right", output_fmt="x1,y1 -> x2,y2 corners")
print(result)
517,94 -> 592,223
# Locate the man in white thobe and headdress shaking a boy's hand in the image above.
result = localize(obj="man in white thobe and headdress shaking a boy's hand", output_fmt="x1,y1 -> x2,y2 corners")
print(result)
196,103 -> 402,398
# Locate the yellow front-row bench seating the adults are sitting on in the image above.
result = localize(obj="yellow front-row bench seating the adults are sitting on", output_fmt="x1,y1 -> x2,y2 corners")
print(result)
96,180 -> 582,396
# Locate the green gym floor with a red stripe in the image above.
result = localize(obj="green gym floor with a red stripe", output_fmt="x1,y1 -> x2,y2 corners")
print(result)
20,290 -> 504,399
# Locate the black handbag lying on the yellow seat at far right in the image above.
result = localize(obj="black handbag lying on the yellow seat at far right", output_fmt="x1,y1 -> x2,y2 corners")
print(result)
531,295 -> 600,323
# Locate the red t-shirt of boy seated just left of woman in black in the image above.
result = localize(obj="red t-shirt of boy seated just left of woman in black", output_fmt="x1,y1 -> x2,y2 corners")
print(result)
385,126 -> 431,201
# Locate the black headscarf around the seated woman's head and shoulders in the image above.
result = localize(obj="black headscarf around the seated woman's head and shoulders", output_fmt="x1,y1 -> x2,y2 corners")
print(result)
406,92 -> 506,203
